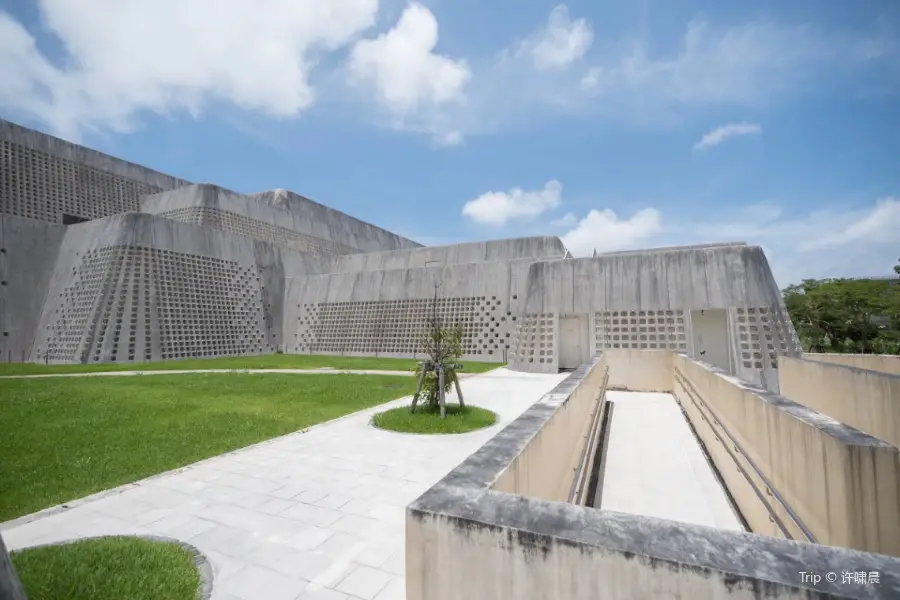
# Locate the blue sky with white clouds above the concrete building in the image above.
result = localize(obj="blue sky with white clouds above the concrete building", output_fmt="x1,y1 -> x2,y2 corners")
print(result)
0,0 -> 900,285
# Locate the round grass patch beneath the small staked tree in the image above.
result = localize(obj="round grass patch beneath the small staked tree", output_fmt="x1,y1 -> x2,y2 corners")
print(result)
372,404 -> 497,433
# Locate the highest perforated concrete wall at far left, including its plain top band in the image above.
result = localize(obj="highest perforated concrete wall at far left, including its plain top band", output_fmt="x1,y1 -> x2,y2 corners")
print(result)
0,120 -> 188,223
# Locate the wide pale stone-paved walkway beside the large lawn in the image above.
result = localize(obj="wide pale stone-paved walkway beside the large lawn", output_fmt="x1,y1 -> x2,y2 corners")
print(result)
0,369 -> 566,600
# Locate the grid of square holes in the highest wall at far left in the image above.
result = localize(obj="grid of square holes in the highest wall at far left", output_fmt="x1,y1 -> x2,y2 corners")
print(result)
0,141 -> 162,223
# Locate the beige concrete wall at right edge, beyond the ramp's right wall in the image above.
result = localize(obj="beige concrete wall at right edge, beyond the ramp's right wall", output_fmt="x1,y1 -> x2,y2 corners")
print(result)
778,357 -> 900,446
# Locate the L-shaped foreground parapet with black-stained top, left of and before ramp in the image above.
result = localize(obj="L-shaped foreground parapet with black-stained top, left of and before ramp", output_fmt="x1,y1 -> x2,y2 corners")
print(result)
406,366 -> 900,600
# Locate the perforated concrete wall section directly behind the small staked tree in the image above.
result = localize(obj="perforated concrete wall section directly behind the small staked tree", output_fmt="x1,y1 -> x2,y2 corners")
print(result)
284,260 -> 531,362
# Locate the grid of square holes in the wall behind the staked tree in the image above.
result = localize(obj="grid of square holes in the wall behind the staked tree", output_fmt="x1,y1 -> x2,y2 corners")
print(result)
293,296 -> 510,356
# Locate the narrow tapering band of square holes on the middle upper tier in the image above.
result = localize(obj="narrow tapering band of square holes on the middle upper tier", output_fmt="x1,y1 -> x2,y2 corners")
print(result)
159,206 -> 359,254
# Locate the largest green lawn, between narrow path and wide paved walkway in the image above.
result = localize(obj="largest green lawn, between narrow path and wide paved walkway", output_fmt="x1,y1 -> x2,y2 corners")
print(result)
0,373 -> 416,522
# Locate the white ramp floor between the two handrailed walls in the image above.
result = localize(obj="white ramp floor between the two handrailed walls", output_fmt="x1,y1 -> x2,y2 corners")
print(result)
600,391 -> 744,531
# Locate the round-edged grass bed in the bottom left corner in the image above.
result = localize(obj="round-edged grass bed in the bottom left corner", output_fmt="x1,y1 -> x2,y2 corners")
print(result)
11,537 -> 200,600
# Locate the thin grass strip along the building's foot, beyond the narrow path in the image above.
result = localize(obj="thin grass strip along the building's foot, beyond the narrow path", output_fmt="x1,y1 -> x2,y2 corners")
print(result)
0,354 -> 503,375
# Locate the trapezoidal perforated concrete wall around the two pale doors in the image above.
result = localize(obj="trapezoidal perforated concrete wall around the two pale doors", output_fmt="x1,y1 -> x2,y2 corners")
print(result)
511,244 -> 800,385
